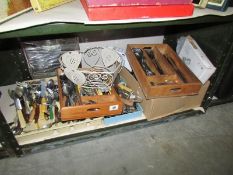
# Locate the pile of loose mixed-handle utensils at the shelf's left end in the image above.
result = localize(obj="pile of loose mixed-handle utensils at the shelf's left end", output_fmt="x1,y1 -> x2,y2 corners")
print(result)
8,79 -> 59,134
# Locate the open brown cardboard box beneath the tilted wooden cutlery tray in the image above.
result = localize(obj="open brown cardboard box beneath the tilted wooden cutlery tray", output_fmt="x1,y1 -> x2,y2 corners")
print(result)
121,69 -> 210,120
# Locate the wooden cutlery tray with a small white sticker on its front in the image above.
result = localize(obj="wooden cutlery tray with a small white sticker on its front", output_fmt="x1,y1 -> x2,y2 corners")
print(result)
57,70 -> 123,121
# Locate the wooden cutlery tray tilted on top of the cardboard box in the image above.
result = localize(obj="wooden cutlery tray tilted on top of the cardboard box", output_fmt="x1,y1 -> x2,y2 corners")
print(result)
127,44 -> 201,99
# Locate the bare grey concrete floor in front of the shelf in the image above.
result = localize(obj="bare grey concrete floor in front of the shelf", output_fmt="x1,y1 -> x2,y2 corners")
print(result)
0,103 -> 233,175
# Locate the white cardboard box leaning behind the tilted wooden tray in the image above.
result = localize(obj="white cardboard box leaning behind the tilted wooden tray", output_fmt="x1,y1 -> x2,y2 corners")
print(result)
178,36 -> 216,84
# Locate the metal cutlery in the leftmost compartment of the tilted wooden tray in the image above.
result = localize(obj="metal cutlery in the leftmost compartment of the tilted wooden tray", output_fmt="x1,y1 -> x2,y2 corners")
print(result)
132,48 -> 155,76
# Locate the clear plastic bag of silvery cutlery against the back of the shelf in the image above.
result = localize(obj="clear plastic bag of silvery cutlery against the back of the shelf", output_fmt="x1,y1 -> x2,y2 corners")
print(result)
21,37 -> 79,79
